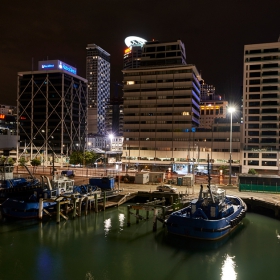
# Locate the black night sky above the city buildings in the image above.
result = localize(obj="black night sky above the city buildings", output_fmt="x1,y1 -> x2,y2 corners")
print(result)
0,0 -> 280,105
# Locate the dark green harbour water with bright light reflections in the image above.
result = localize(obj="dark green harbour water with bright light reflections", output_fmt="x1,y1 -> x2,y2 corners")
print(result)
0,205 -> 280,280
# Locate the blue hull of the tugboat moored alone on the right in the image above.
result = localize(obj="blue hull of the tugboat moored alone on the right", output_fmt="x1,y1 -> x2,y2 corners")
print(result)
166,197 -> 246,240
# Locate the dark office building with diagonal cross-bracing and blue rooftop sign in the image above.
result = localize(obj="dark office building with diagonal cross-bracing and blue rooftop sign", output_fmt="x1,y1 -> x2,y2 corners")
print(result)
17,60 -> 87,164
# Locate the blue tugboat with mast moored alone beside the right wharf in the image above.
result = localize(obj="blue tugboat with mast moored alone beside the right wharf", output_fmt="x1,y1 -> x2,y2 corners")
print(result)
165,156 -> 247,240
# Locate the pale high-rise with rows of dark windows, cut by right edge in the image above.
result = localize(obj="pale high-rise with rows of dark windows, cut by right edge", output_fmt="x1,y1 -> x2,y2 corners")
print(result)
243,42 -> 280,172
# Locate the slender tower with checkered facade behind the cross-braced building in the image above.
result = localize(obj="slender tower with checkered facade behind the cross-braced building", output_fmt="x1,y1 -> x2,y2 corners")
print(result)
86,44 -> 110,135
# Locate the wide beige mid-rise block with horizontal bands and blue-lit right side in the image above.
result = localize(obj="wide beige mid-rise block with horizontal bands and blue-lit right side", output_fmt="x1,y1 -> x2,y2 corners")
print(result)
123,40 -> 200,160
